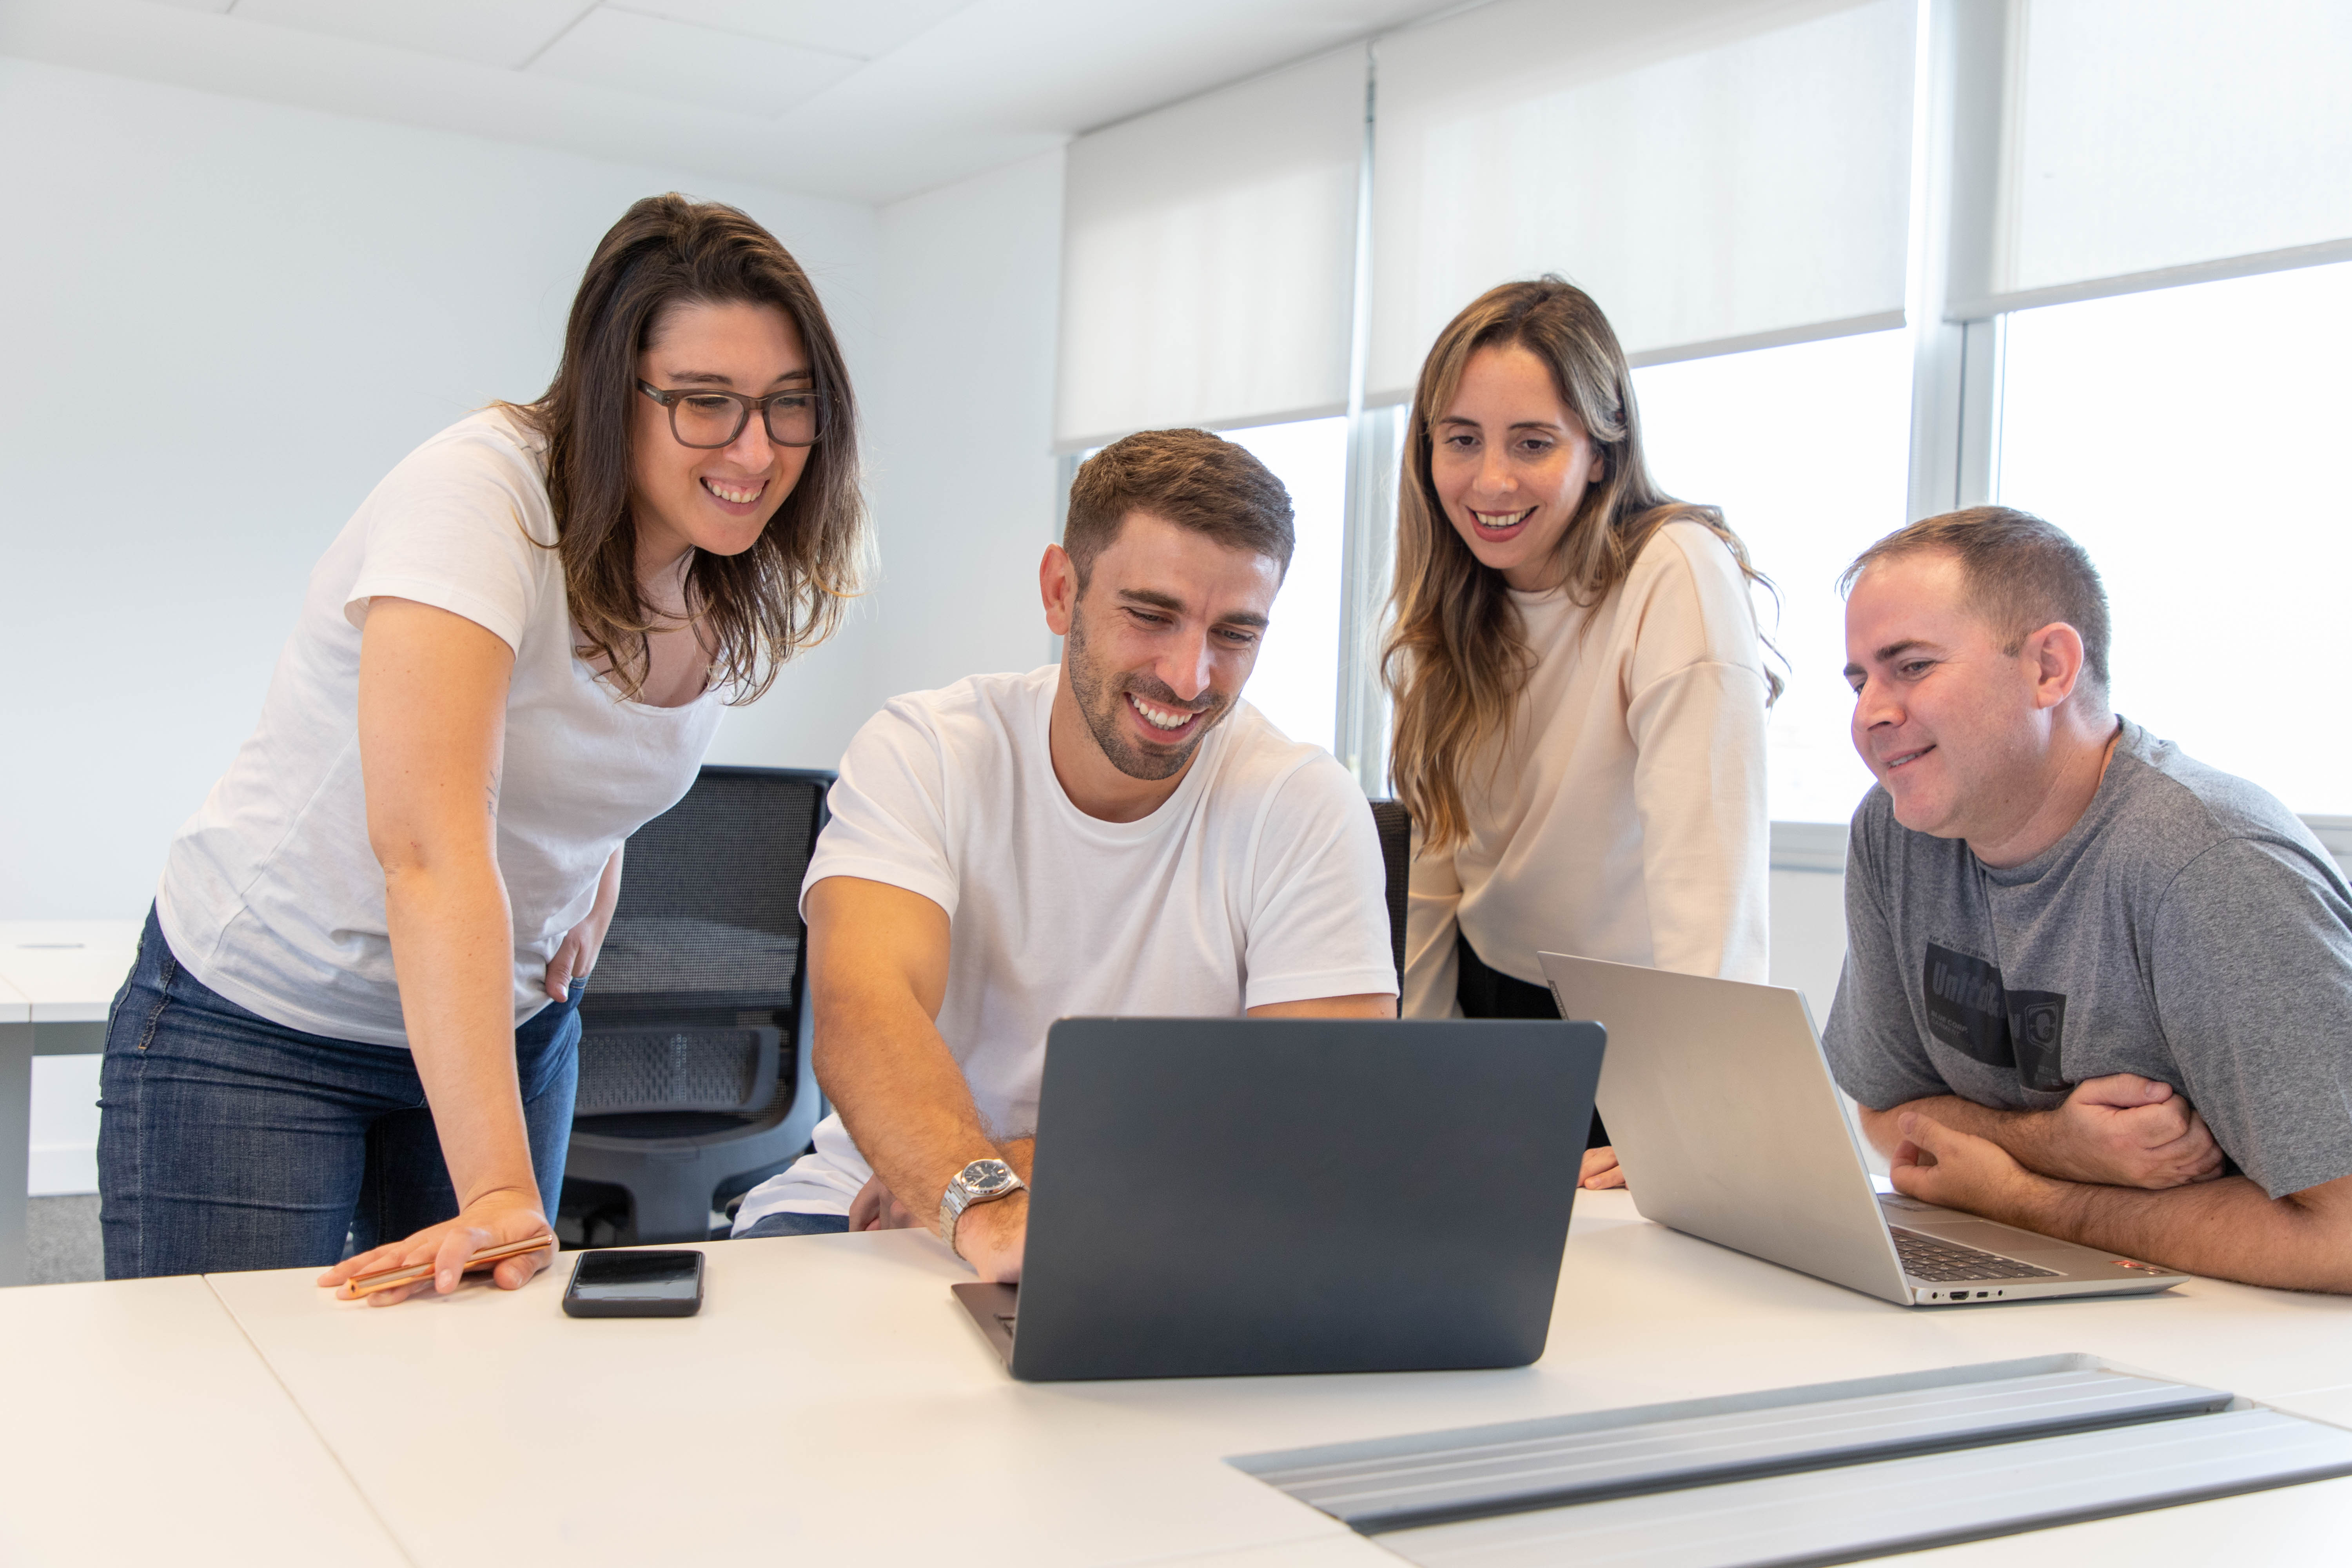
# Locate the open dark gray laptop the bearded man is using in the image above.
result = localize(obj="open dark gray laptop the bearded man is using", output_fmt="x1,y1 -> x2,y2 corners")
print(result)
955,1018 -> 1602,1382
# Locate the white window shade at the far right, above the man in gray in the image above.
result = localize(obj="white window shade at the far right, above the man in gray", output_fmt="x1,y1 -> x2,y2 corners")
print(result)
1955,0 -> 2352,315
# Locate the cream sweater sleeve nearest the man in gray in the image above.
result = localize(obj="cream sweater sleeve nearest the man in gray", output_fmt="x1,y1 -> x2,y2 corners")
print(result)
1625,524 -> 1771,983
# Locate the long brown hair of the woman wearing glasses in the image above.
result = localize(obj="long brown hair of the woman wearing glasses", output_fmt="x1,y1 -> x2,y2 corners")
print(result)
508,193 -> 866,703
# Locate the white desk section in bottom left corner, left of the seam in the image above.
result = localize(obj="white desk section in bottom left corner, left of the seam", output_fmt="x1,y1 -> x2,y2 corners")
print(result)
0,1276 -> 402,1568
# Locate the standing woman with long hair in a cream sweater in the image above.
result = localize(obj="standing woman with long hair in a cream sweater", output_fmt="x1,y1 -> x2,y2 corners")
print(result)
1383,278 -> 1778,1187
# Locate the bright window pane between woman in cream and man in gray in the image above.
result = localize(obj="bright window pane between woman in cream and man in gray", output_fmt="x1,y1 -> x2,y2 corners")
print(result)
1635,332 -> 1912,823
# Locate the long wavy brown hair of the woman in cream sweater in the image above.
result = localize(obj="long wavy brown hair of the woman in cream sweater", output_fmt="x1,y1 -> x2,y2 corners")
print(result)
1381,275 -> 1780,849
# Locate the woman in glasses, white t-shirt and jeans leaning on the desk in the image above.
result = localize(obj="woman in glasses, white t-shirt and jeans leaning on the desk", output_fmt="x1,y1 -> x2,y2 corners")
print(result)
99,195 -> 866,1305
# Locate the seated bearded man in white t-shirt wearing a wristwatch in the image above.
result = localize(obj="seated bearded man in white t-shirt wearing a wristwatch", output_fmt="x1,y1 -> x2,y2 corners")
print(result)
734,430 -> 1397,1281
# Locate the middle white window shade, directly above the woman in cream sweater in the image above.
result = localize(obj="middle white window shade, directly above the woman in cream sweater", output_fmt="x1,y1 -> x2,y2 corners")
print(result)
1367,0 -> 1917,402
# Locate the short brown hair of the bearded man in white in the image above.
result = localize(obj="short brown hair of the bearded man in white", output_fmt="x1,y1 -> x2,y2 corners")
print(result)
1061,430 -> 1296,592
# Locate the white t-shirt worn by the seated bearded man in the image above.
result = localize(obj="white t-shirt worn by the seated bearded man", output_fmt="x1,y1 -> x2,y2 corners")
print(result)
736,665 -> 1397,1229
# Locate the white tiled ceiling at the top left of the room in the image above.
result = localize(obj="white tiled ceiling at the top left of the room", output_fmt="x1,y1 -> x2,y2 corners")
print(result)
0,0 -> 1458,202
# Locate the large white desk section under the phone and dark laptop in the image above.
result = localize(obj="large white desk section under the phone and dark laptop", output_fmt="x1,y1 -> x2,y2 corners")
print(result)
198,1194 -> 2352,1568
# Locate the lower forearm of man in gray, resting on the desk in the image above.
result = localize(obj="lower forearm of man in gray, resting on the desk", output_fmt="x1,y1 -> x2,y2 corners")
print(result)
1893,1117 -> 2352,1295
